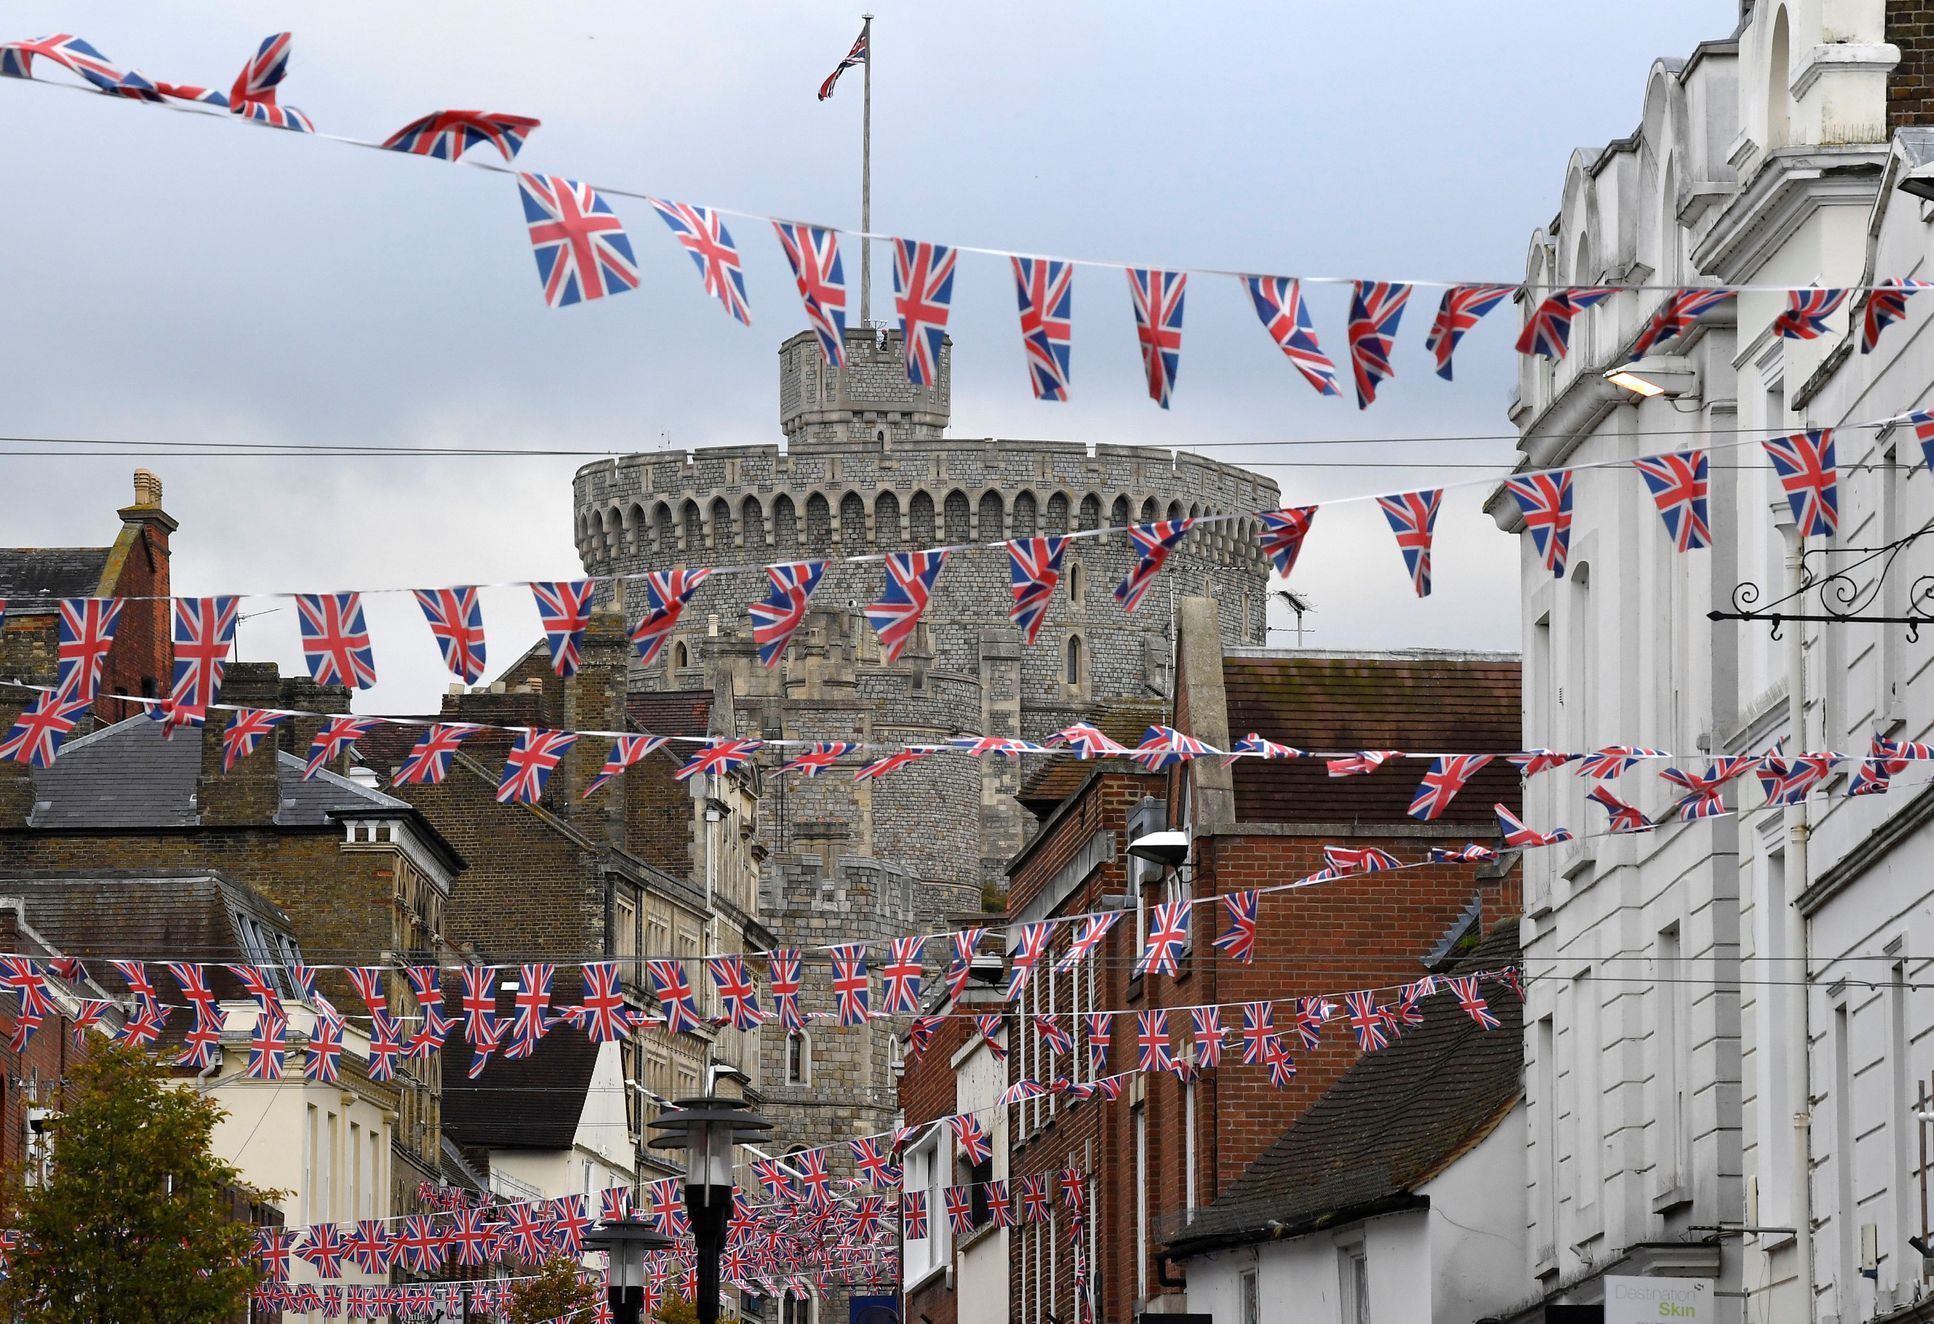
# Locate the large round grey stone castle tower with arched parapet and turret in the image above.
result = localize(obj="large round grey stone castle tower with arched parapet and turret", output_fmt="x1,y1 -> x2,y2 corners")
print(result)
574,329 -> 1280,912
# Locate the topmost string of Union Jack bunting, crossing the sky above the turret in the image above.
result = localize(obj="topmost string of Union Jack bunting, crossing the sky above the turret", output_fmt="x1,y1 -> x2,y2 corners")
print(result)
11,33 -> 1930,408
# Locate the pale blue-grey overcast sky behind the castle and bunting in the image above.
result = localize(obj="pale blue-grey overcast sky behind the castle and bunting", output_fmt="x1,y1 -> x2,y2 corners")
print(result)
0,0 -> 1737,711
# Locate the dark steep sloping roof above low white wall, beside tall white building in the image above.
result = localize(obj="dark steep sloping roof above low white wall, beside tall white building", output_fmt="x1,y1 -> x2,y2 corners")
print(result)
1168,920 -> 1524,1251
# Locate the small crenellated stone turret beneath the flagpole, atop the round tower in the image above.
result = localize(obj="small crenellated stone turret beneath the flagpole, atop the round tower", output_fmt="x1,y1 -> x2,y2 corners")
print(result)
779,327 -> 953,450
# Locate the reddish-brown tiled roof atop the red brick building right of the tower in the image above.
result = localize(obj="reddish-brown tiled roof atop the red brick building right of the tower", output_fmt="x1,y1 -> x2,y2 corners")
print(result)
1222,653 -> 1522,823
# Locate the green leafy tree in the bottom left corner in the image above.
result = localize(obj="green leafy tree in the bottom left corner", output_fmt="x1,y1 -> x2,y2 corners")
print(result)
0,1044 -> 257,1324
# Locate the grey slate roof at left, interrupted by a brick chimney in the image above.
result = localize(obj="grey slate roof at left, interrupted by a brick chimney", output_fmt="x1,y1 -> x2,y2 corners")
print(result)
29,717 -> 412,831
